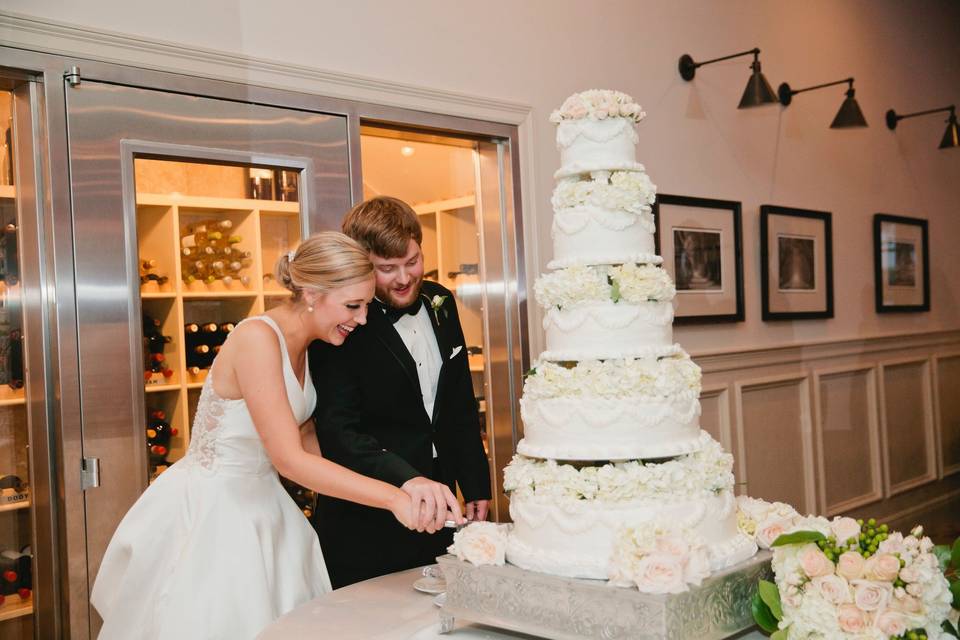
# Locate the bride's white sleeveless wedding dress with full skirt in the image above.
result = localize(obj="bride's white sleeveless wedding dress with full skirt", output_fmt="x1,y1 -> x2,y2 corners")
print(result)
90,316 -> 330,640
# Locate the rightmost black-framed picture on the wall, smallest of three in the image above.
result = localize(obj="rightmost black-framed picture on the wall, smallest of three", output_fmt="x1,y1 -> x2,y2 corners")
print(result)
873,213 -> 930,313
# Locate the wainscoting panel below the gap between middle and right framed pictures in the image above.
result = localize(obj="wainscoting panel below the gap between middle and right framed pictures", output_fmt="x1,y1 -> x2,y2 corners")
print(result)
814,366 -> 883,515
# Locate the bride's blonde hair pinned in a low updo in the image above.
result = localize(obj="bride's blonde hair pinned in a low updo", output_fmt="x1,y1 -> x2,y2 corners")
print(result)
275,231 -> 373,302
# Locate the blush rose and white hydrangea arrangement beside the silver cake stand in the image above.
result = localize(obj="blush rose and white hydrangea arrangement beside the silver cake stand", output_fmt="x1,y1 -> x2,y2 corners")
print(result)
738,498 -> 960,640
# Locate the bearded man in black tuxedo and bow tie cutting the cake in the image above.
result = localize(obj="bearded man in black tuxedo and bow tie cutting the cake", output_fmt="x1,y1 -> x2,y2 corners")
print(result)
310,196 -> 490,588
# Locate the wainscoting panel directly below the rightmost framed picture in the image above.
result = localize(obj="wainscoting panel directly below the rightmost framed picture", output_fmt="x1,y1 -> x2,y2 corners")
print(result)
881,360 -> 937,495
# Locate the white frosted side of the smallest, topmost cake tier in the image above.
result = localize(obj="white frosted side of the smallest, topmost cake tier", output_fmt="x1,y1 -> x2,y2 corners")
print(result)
557,118 -> 643,177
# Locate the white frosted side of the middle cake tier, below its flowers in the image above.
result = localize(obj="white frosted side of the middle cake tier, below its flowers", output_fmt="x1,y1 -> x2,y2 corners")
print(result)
542,302 -> 673,360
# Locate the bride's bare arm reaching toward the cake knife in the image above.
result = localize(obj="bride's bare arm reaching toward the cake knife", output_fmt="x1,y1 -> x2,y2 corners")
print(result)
226,322 -> 464,532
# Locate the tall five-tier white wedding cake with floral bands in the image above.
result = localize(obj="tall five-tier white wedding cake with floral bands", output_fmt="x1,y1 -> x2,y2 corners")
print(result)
504,91 -> 757,588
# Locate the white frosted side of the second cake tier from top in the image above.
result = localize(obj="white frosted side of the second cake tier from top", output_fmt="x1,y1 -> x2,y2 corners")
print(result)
547,206 -> 663,269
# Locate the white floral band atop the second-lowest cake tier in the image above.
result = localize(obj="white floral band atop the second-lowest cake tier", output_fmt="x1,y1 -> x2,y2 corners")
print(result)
523,354 -> 701,399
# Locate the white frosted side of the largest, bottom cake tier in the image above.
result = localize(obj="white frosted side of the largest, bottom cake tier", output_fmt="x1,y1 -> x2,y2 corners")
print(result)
507,491 -> 757,579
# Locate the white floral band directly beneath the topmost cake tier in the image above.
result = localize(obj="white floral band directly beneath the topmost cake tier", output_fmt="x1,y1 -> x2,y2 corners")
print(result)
550,171 -> 657,219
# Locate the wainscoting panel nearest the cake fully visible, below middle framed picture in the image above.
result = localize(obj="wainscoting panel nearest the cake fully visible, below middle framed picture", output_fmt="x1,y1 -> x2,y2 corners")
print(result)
736,376 -> 816,512
